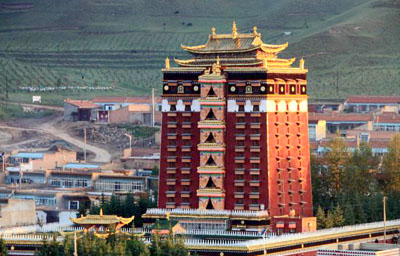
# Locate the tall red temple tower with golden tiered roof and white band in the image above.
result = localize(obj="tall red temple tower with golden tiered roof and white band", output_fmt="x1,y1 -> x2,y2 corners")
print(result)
159,23 -> 313,217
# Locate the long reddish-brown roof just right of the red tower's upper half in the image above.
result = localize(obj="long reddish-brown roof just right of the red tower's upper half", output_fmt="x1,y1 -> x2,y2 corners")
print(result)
308,112 -> 373,122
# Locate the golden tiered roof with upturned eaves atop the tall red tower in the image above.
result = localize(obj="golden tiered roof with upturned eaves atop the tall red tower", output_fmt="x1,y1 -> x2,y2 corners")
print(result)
172,22 -> 304,70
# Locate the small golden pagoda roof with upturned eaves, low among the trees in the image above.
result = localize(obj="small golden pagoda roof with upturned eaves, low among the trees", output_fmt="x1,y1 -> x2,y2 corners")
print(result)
71,209 -> 135,225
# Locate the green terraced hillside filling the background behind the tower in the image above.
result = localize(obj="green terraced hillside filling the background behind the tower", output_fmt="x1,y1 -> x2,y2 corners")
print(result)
0,0 -> 400,104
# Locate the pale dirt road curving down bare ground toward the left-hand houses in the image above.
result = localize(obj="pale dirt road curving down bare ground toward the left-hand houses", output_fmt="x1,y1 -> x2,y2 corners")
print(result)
0,117 -> 111,163
